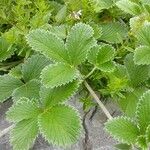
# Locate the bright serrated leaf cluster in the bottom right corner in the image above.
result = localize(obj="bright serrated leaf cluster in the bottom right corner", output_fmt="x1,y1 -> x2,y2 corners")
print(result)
105,91 -> 150,149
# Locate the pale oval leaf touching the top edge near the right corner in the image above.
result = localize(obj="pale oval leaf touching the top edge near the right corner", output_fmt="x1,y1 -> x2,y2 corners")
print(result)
116,0 -> 141,15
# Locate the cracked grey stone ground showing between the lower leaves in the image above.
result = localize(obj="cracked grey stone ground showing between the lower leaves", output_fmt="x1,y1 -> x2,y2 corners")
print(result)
0,99 -> 118,150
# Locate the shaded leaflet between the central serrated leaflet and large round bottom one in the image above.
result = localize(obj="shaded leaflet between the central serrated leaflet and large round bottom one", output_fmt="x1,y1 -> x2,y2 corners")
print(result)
40,81 -> 79,107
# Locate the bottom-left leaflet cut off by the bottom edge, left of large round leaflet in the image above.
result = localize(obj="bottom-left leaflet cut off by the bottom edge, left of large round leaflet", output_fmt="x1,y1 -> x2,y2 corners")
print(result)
10,119 -> 38,150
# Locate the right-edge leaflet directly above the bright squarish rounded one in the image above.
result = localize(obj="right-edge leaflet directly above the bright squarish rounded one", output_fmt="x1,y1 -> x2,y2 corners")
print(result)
137,22 -> 150,46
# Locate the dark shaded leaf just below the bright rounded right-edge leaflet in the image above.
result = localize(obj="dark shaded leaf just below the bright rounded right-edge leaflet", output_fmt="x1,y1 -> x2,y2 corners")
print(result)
125,54 -> 148,87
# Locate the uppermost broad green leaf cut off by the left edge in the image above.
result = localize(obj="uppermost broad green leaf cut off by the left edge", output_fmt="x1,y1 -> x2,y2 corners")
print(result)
0,37 -> 14,61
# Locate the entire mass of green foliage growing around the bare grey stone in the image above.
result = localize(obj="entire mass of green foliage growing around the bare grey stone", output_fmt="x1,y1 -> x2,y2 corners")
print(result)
0,0 -> 150,150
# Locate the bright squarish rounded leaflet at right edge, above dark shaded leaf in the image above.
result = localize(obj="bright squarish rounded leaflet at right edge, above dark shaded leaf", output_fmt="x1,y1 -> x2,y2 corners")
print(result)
134,46 -> 150,65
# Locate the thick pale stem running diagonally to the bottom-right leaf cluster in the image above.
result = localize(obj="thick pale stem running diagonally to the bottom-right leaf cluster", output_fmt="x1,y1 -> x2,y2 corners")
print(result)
84,81 -> 113,119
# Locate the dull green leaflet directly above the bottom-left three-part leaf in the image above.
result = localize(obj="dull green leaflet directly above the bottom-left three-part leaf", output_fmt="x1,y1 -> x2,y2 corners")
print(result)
12,80 -> 40,101
